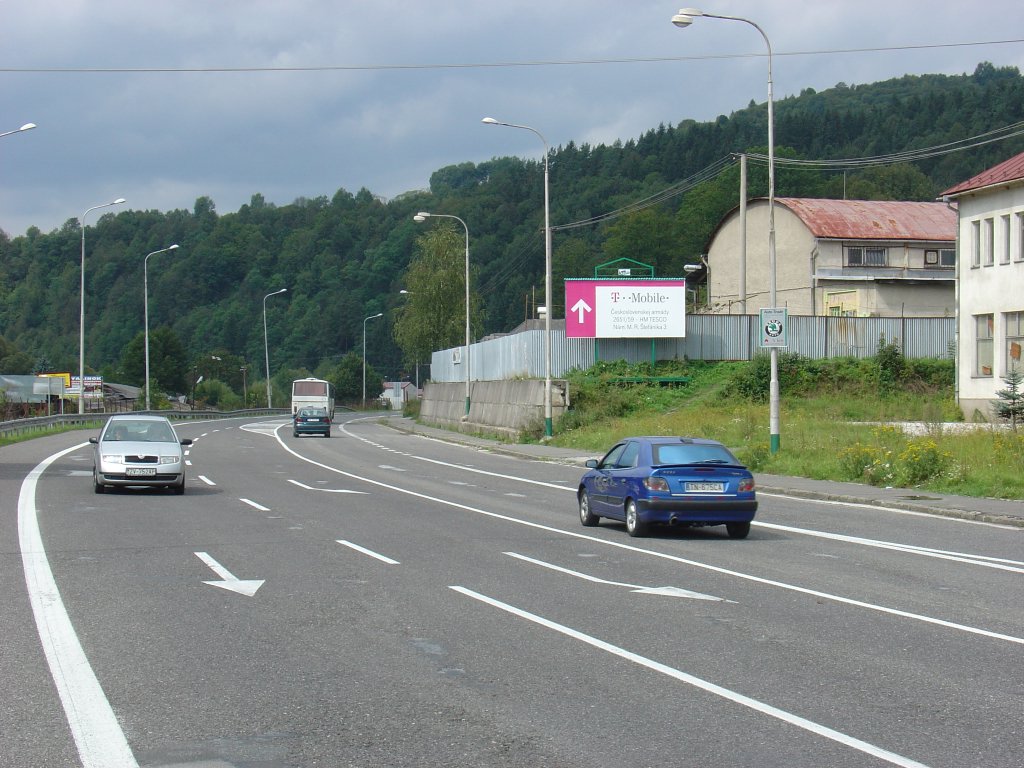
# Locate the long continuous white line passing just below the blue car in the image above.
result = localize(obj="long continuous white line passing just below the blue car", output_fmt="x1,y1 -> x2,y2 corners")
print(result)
274,433 -> 1024,645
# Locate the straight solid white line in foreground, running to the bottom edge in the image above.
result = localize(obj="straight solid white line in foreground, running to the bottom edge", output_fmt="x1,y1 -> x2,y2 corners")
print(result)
449,586 -> 927,768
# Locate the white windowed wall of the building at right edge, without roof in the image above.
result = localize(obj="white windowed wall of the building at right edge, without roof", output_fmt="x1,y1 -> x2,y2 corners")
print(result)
956,187 -> 1024,420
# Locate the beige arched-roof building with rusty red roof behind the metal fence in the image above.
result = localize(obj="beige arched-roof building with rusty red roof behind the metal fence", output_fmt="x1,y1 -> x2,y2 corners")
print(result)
707,198 -> 956,317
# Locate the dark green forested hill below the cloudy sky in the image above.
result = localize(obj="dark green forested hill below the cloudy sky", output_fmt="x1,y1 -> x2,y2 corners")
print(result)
0,63 -> 1024,391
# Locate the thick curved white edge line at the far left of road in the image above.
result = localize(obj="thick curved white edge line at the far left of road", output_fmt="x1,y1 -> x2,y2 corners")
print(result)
17,442 -> 138,768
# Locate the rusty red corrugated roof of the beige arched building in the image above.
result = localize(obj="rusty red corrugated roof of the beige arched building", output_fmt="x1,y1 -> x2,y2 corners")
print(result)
775,198 -> 956,243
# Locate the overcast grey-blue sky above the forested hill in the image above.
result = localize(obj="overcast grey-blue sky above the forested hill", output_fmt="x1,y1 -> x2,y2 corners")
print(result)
0,0 -> 1024,237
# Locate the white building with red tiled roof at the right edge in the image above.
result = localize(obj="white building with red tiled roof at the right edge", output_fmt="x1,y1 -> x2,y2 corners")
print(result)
943,153 -> 1024,420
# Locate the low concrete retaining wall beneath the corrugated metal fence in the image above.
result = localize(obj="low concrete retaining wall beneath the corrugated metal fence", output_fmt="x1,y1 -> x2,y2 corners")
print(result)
420,379 -> 568,438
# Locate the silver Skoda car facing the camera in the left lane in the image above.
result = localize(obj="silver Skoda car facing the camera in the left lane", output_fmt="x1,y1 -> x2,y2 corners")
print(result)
89,414 -> 191,495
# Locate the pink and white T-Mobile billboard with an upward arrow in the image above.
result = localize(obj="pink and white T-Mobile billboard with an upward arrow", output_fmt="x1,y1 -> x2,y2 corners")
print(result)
565,278 -> 686,339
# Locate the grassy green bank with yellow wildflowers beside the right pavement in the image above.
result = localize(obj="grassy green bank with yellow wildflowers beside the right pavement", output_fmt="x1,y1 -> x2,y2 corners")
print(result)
554,349 -> 1024,499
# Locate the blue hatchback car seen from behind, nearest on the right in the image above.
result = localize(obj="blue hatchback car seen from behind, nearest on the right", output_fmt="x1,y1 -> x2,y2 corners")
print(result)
577,437 -> 758,539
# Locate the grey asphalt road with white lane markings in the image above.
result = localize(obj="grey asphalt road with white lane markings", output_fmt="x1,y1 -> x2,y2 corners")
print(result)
0,419 -> 1024,768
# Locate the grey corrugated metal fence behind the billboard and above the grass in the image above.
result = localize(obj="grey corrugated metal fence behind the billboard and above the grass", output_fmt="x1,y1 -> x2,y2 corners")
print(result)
430,314 -> 956,381
